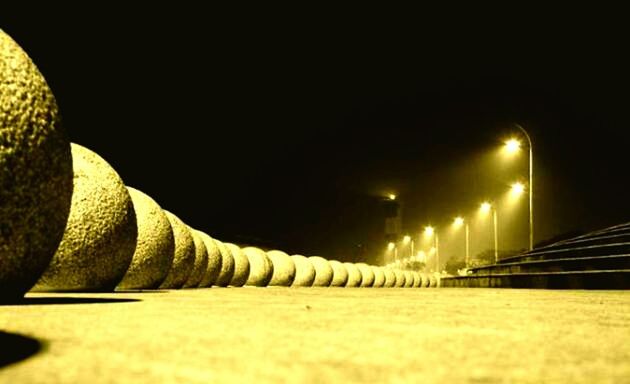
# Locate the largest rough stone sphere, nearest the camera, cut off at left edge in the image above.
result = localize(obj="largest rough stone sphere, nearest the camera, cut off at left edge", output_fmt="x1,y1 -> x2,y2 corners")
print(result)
0,30 -> 73,302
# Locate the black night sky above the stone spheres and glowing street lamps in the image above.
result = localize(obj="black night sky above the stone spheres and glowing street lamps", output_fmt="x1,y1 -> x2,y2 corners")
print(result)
0,3 -> 630,260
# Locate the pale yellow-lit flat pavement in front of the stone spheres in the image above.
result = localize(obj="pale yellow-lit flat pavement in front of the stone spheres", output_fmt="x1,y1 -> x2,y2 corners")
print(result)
0,287 -> 630,383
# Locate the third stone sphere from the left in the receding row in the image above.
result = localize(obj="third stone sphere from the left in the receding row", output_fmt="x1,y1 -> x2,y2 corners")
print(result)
116,187 -> 175,289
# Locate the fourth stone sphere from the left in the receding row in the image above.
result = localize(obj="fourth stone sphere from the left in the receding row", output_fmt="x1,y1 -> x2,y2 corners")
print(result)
160,210 -> 195,289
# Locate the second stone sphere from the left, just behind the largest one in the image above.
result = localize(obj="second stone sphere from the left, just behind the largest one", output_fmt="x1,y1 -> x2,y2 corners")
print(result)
33,144 -> 138,292
